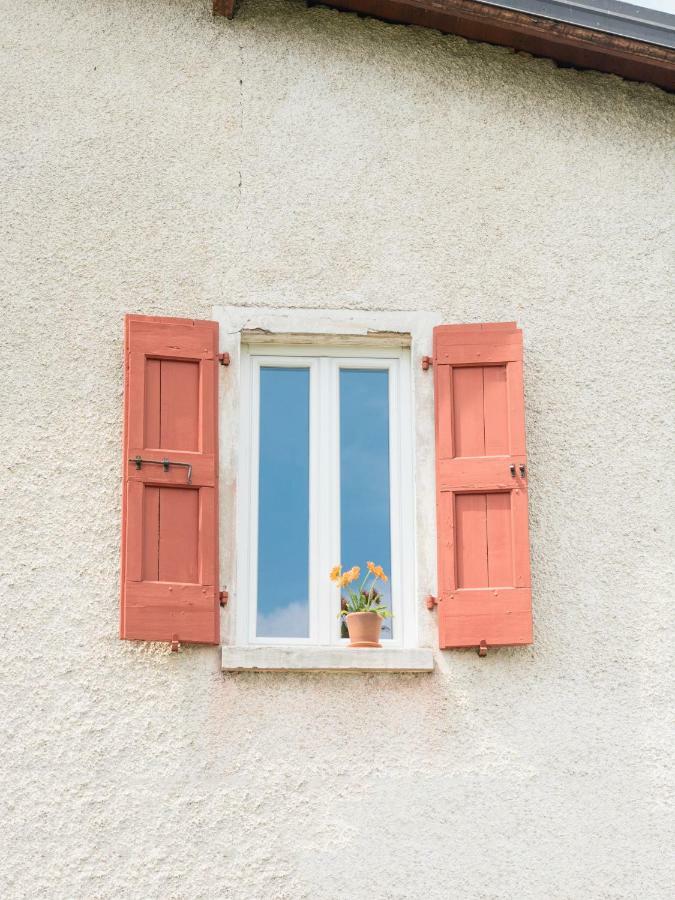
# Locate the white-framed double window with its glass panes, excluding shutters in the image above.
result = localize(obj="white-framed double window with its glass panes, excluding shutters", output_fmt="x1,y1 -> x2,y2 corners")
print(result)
238,344 -> 416,647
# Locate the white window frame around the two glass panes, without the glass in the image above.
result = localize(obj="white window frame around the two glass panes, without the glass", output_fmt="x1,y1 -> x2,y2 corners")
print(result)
236,342 -> 418,648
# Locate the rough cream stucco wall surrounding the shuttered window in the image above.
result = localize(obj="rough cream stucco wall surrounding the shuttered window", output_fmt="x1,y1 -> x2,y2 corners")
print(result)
0,0 -> 675,900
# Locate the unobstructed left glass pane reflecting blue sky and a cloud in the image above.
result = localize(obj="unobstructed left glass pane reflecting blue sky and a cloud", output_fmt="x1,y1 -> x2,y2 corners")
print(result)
257,367 -> 309,637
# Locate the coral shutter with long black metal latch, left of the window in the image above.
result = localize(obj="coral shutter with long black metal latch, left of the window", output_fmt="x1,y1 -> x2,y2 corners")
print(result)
121,316 -> 220,644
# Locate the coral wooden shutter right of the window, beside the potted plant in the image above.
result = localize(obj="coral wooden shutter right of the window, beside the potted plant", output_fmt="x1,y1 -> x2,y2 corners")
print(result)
433,322 -> 532,648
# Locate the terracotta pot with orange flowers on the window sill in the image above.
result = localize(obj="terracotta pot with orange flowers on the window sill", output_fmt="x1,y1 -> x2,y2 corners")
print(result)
330,562 -> 392,647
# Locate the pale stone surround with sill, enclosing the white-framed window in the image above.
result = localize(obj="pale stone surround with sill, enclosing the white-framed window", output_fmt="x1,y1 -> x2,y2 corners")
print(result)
213,306 -> 442,672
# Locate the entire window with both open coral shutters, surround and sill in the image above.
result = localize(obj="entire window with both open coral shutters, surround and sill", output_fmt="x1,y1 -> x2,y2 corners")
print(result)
120,307 -> 532,672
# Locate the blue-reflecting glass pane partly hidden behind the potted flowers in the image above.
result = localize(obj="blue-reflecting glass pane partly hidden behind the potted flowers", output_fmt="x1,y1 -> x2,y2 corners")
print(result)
340,369 -> 393,638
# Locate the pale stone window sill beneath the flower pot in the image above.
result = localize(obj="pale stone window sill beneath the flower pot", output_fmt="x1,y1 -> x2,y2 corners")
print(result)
222,646 -> 434,672
